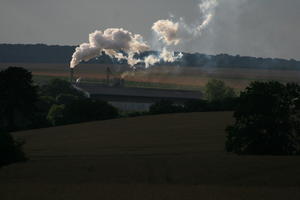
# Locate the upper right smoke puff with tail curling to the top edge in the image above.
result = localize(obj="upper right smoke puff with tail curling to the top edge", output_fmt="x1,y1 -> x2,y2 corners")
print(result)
152,0 -> 218,45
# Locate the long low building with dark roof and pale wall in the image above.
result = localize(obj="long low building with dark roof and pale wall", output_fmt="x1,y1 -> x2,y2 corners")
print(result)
76,83 -> 202,111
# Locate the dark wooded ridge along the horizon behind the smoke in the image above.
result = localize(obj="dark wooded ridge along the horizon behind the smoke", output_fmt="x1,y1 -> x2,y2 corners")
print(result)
0,44 -> 300,70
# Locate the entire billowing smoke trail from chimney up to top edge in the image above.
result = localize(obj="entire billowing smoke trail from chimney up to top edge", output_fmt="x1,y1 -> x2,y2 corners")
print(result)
70,0 -> 218,68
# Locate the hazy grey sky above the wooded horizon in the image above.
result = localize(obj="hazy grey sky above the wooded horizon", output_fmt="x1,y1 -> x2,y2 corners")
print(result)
0,0 -> 300,60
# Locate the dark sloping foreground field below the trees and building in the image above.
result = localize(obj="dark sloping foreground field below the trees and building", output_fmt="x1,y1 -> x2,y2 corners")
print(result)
0,112 -> 300,200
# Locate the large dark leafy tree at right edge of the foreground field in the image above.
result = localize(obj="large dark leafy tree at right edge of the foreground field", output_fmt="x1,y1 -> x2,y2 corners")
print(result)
226,82 -> 300,155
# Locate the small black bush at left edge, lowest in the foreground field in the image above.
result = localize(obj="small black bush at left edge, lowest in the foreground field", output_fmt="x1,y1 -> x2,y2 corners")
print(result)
0,132 -> 26,167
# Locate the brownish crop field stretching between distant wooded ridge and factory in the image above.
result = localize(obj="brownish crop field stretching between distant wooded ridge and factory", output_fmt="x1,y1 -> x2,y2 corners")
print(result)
0,63 -> 300,90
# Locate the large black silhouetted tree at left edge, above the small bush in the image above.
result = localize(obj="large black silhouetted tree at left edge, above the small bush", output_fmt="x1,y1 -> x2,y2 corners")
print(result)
0,67 -> 37,131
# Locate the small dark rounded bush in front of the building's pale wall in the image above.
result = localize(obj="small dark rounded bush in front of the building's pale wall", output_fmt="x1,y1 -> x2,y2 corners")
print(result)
149,100 -> 184,114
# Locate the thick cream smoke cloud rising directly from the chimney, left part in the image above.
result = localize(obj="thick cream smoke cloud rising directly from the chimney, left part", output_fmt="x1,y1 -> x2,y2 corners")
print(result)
70,28 -> 150,68
